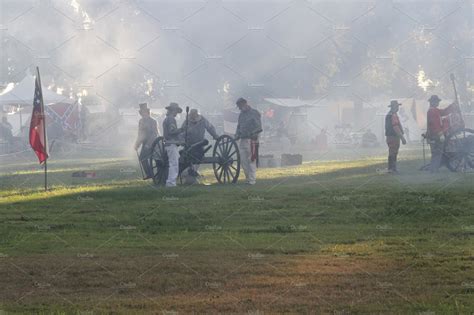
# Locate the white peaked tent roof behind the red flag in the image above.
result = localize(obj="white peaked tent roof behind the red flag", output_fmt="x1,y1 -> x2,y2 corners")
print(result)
0,75 -> 68,105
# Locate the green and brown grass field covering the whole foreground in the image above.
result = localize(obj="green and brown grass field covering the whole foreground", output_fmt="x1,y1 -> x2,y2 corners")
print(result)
0,149 -> 474,314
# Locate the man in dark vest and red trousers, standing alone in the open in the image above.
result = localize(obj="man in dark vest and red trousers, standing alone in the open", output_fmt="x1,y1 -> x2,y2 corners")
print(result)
385,100 -> 407,174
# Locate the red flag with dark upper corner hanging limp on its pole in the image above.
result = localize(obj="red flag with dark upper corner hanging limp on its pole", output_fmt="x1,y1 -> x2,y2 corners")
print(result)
30,71 -> 48,164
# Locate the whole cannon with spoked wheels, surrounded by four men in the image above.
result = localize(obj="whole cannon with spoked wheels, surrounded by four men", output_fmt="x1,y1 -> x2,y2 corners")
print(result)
150,135 -> 240,185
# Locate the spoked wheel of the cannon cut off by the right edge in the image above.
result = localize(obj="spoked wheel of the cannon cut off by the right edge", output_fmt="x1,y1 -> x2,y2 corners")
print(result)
444,128 -> 474,172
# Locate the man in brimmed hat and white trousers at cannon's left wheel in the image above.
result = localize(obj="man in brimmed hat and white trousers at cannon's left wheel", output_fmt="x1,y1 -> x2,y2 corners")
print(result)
163,103 -> 183,187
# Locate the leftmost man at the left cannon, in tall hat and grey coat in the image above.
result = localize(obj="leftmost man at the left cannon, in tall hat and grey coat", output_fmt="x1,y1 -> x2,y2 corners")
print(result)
134,103 -> 158,179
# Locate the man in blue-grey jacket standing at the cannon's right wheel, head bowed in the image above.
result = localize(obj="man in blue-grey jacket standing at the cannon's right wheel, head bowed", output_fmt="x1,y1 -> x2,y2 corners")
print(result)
235,98 -> 262,185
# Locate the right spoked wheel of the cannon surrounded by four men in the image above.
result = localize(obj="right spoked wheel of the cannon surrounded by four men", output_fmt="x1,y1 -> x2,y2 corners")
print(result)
212,135 -> 240,184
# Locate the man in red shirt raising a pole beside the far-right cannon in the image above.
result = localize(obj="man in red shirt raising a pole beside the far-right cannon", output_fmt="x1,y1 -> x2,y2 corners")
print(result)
426,95 -> 456,173
